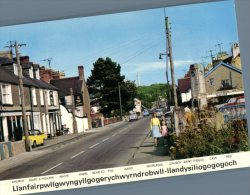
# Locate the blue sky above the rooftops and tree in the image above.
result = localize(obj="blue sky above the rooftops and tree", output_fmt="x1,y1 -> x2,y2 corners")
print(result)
0,0 -> 239,85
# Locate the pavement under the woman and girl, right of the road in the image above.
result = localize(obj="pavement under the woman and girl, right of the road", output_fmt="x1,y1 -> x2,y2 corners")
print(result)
129,134 -> 171,165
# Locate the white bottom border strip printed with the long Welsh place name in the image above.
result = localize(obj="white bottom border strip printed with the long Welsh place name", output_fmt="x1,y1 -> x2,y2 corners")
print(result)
0,151 -> 250,195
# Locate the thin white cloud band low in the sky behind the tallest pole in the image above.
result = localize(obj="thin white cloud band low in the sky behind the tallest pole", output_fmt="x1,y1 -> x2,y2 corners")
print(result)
124,60 -> 198,72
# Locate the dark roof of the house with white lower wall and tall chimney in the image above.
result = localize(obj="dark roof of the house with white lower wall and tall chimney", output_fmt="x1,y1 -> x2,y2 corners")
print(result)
50,77 -> 83,97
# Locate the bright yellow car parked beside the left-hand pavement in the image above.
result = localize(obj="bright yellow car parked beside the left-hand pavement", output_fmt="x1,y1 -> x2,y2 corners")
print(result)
23,129 -> 47,148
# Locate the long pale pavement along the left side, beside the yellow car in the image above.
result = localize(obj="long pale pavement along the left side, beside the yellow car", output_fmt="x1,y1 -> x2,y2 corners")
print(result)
0,121 -> 124,174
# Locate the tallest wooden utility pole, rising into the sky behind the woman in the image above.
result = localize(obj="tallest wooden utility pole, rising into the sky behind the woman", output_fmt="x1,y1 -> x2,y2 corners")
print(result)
165,17 -> 178,108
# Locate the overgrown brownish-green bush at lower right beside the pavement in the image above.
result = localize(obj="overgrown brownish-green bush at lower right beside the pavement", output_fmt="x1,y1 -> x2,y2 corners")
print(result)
168,120 -> 249,159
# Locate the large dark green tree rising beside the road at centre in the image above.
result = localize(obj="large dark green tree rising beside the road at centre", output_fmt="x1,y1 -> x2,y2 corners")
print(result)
87,58 -> 136,115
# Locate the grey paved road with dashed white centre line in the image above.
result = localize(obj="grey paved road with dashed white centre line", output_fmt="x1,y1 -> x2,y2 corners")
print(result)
0,118 -> 149,180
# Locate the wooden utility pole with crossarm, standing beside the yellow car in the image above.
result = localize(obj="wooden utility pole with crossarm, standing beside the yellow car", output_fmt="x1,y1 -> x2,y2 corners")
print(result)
13,41 -> 31,152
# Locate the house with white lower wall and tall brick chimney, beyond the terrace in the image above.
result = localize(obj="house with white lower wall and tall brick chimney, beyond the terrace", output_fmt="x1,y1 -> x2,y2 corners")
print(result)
50,66 -> 91,133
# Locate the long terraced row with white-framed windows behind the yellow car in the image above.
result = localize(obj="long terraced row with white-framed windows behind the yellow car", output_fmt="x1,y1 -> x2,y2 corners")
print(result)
0,56 -> 61,142
